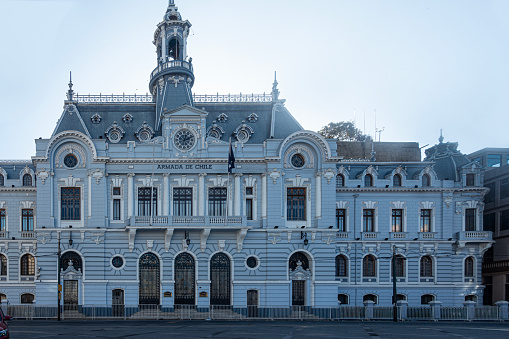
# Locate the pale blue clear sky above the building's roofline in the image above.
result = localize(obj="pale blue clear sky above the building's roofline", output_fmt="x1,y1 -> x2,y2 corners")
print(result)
0,0 -> 509,159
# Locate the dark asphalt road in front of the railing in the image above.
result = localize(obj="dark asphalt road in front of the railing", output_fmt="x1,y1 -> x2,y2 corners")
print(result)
9,320 -> 509,339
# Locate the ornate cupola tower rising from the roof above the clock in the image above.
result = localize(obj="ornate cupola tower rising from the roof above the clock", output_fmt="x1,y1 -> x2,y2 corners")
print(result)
149,0 -> 194,130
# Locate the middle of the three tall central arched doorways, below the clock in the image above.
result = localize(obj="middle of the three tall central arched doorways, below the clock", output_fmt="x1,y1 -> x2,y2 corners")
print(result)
175,252 -> 195,305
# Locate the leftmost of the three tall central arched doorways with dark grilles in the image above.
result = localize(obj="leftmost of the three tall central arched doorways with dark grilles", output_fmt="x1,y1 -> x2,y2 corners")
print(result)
139,253 -> 161,305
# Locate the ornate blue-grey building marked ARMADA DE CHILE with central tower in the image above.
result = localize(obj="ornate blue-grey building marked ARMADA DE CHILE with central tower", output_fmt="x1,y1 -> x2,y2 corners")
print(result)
0,0 -> 492,308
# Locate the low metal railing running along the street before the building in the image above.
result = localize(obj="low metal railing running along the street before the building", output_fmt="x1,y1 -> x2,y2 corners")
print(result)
2,304 -> 509,321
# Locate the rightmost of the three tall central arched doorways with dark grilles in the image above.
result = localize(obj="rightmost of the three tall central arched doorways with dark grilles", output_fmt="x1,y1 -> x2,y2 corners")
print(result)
210,253 -> 231,305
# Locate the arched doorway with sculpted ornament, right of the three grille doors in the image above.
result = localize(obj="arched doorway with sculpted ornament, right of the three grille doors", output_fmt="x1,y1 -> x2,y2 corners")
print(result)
288,252 -> 311,306
